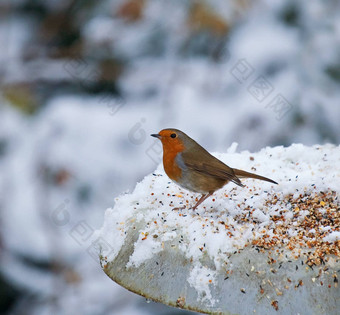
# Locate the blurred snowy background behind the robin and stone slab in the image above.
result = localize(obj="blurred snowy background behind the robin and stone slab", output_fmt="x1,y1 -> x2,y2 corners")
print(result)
0,0 -> 340,314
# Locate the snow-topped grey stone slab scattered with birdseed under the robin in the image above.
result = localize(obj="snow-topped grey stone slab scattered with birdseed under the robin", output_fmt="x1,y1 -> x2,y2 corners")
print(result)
95,144 -> 340,314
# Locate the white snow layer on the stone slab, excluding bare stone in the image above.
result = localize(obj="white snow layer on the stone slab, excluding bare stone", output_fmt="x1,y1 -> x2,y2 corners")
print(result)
97,144 -> 340,303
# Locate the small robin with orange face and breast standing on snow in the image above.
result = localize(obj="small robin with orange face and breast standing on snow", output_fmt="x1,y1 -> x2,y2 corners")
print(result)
151,129 -> 277,210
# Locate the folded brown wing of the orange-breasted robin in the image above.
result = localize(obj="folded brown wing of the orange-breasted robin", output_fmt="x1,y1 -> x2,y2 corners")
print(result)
181,147 -> 244,187
